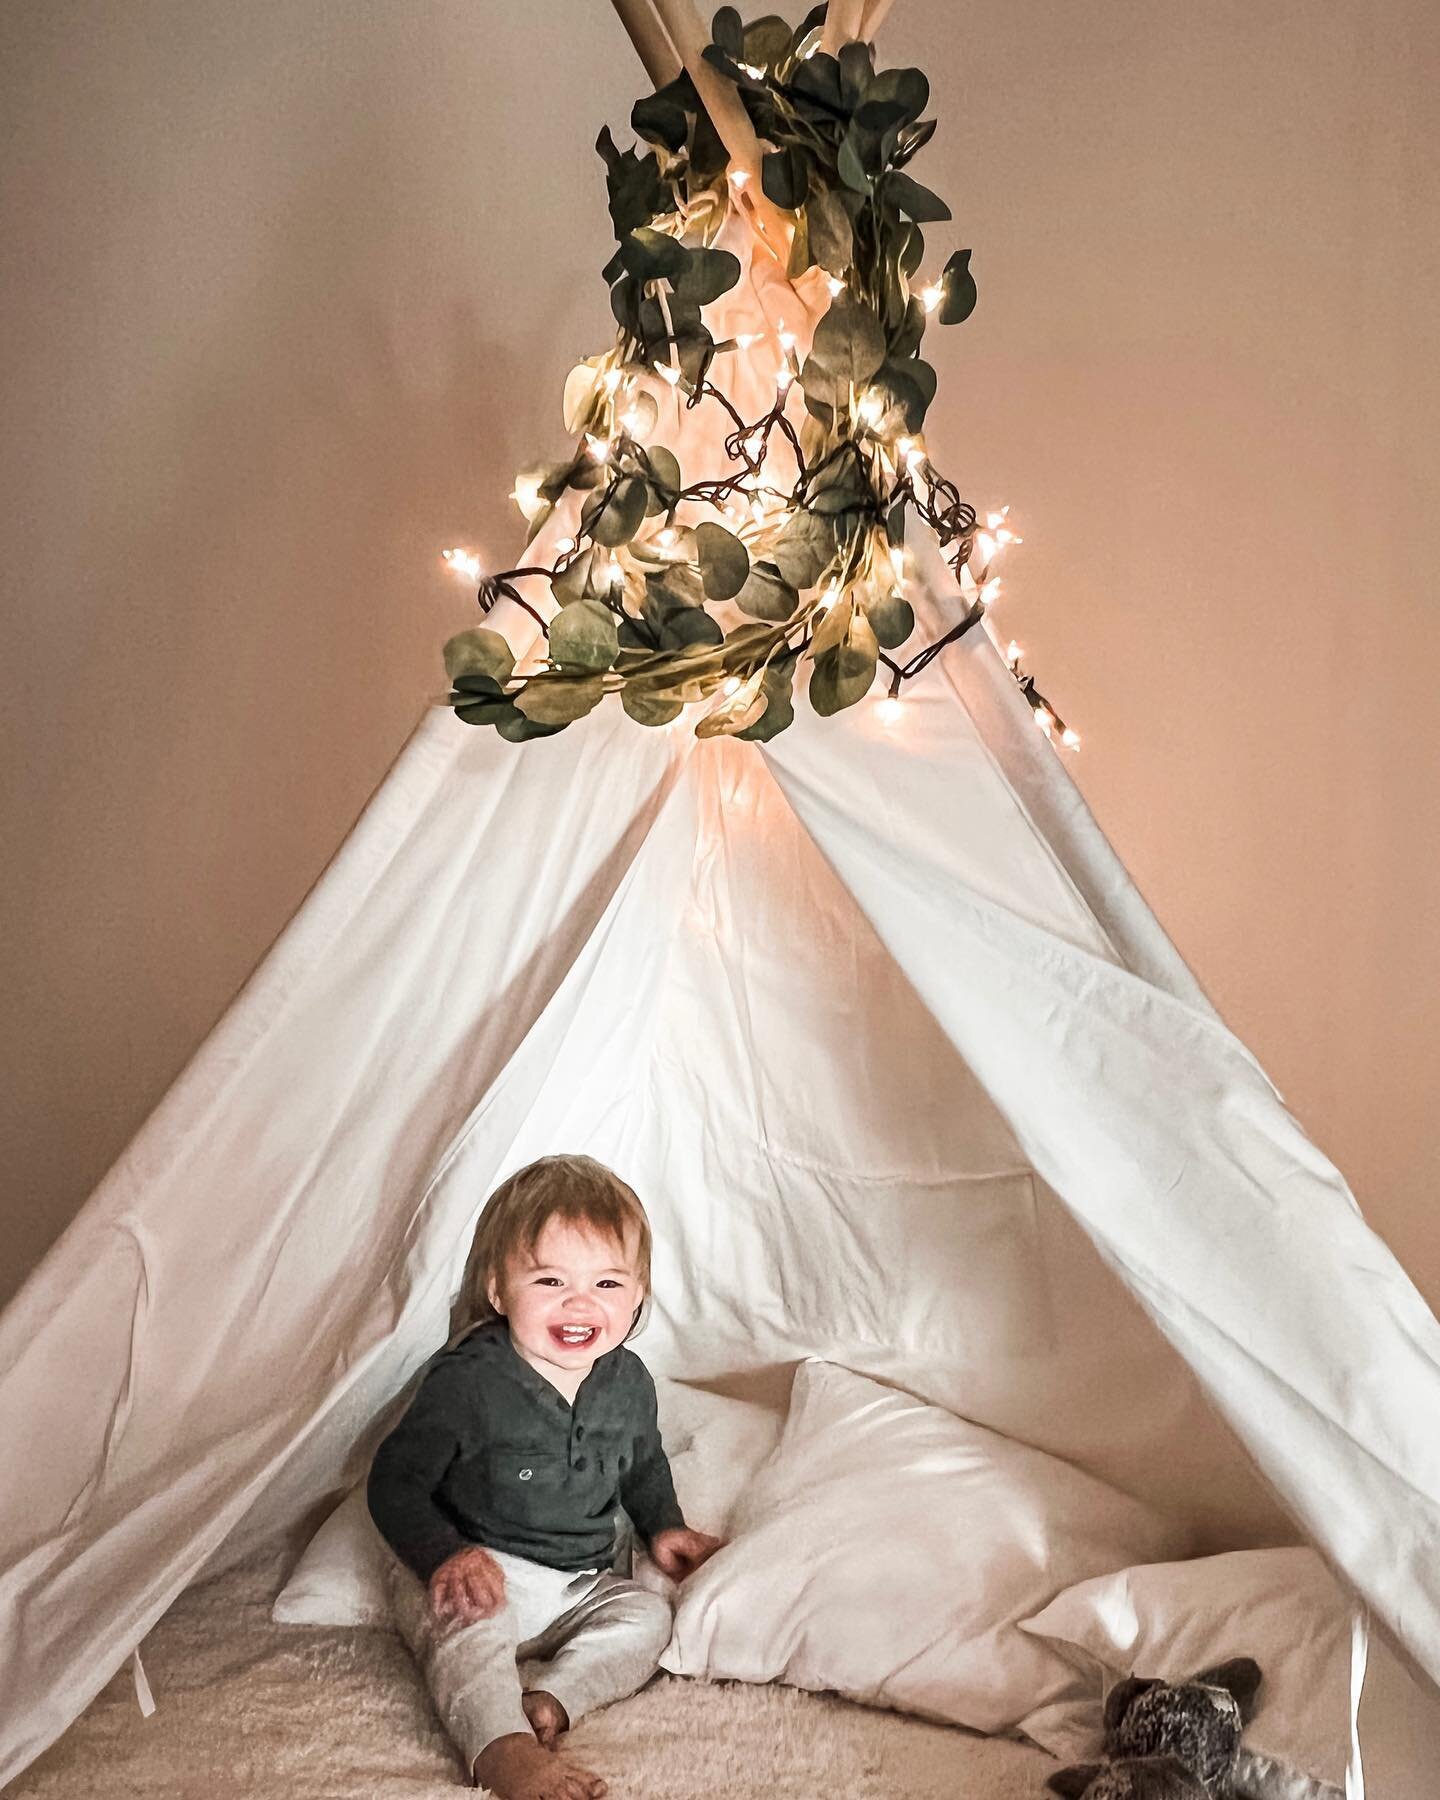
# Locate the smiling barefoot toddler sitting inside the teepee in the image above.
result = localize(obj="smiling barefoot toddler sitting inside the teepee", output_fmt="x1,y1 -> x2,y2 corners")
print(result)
367,1156 -> 718,1800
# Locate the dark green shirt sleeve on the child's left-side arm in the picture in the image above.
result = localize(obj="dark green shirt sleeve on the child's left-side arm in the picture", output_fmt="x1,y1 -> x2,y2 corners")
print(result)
365,1359 -> 475,1582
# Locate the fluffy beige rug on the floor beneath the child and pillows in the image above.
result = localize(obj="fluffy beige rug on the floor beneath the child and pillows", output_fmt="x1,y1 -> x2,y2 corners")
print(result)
5,1555 -> 1055,1800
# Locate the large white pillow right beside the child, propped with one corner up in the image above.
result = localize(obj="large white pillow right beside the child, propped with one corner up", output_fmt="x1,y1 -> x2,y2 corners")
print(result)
662,1361 -> 1183,1732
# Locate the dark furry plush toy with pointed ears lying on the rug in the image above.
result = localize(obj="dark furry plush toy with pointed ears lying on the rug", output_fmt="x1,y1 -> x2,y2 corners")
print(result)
1046,1656 -> 1260,1800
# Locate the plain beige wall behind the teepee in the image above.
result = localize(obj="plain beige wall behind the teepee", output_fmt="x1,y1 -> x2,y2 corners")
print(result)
0,0 -> 1440,1301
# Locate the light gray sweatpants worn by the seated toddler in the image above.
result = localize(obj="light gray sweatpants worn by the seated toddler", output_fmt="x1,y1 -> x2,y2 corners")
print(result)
389,1550 -> 671,1780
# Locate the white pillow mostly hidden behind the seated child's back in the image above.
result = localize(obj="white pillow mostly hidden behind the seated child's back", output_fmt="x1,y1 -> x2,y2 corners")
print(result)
270,1379 -> 783,1625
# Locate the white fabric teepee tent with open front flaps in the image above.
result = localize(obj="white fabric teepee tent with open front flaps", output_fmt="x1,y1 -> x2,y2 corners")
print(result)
0,5 -> 1440,1780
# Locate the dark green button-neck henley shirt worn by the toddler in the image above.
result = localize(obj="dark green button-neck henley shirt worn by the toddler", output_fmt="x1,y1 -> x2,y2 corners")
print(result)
365,1319 -> 684,1582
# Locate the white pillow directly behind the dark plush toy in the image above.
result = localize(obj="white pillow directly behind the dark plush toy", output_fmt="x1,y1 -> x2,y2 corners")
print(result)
1021,1548 -> 1440,1800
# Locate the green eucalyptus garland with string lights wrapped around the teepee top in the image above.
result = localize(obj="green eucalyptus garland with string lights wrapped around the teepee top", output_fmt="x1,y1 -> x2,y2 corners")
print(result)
445,5 -> 1073,742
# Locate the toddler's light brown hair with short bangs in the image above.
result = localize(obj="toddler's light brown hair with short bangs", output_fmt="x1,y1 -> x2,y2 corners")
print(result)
450,1156 -> 650,1345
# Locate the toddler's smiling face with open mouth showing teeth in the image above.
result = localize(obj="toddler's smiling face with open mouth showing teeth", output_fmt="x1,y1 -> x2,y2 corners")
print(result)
490,1219 -> 644,1393
